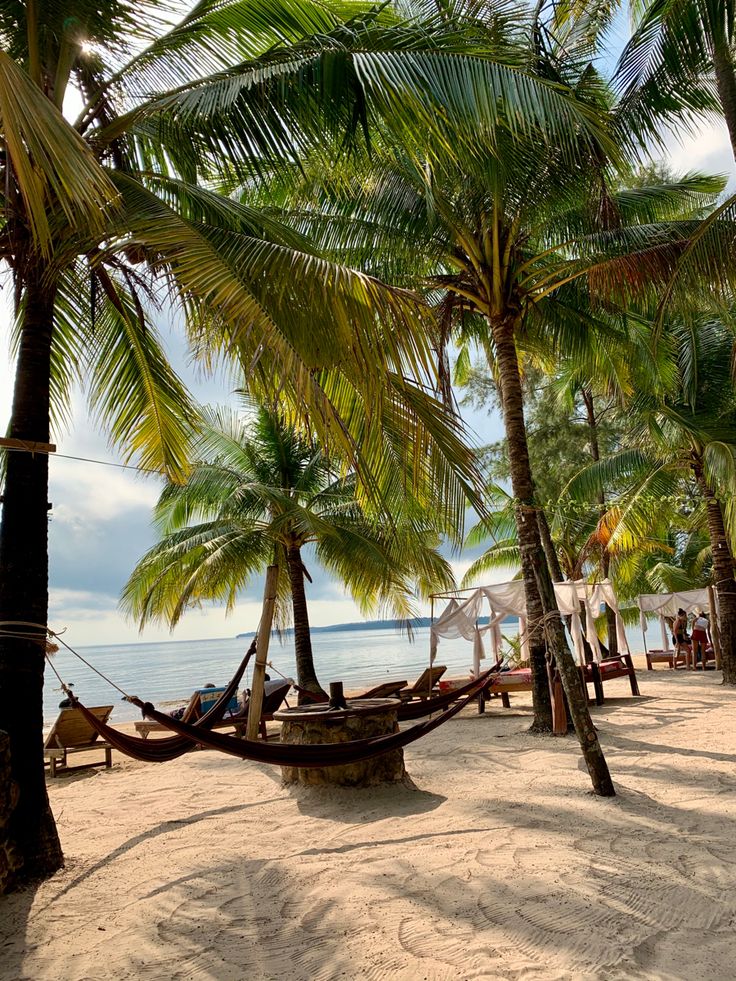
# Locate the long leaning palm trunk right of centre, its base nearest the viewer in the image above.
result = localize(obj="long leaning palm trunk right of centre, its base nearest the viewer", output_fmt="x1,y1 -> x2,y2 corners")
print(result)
490,317 -> 615,797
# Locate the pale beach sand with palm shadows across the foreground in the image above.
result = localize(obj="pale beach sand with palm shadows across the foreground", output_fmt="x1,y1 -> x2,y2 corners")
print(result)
0,669 -> 736,981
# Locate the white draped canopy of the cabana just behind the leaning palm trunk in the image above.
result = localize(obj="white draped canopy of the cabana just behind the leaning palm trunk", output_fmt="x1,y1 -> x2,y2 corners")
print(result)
430,579 -> 629,674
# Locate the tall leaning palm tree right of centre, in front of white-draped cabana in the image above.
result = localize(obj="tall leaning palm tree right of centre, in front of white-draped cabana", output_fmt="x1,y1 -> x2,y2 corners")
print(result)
274,28 -> 736,787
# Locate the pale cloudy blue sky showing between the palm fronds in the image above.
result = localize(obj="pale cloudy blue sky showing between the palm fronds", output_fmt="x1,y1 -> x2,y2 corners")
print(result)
0,26 -> 735,646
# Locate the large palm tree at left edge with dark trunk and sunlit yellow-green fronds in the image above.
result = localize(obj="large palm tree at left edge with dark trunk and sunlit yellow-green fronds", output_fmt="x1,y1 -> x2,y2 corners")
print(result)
0,0 -> 640,881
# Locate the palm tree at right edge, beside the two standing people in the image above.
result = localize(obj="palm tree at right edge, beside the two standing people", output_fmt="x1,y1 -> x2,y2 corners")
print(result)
570,316 -> 736,685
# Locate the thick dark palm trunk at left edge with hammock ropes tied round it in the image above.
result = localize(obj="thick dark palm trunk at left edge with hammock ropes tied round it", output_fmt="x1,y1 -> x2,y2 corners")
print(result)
0,268 -> 64,888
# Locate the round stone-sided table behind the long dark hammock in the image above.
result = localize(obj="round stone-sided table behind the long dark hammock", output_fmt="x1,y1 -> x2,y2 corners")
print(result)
273,698 -> 406,787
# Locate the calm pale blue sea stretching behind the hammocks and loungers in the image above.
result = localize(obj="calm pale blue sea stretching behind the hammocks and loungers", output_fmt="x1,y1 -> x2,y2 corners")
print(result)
44,623 -> 641,725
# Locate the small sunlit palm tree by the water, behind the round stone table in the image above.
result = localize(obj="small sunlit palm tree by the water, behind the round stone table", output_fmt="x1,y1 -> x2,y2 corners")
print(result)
122,408 -> 454,694
